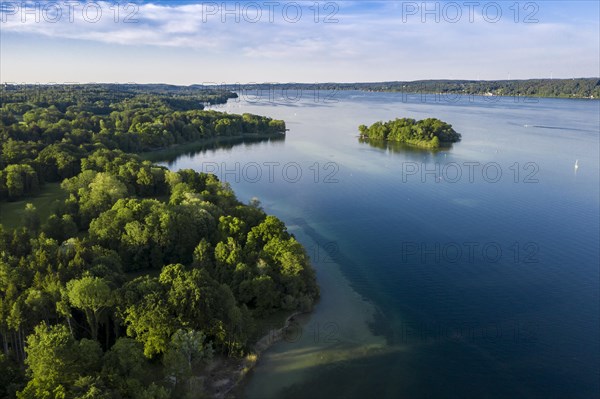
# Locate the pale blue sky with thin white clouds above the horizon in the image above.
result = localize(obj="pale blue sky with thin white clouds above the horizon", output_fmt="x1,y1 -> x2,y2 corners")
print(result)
0,0 -> 600,85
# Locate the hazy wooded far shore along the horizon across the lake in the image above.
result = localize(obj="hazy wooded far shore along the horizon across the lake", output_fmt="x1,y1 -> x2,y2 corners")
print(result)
229,78 -> 600,101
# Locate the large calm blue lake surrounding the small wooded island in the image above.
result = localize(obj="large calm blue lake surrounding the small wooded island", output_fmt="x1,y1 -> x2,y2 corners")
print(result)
157,91 -> 600,398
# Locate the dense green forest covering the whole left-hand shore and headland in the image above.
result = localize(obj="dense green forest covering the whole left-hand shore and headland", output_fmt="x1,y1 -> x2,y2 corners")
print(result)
0,86 -> 319,399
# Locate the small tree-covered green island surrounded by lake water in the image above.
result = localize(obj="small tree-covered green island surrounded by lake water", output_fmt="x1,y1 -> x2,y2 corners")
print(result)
358,118 -> 461,149
